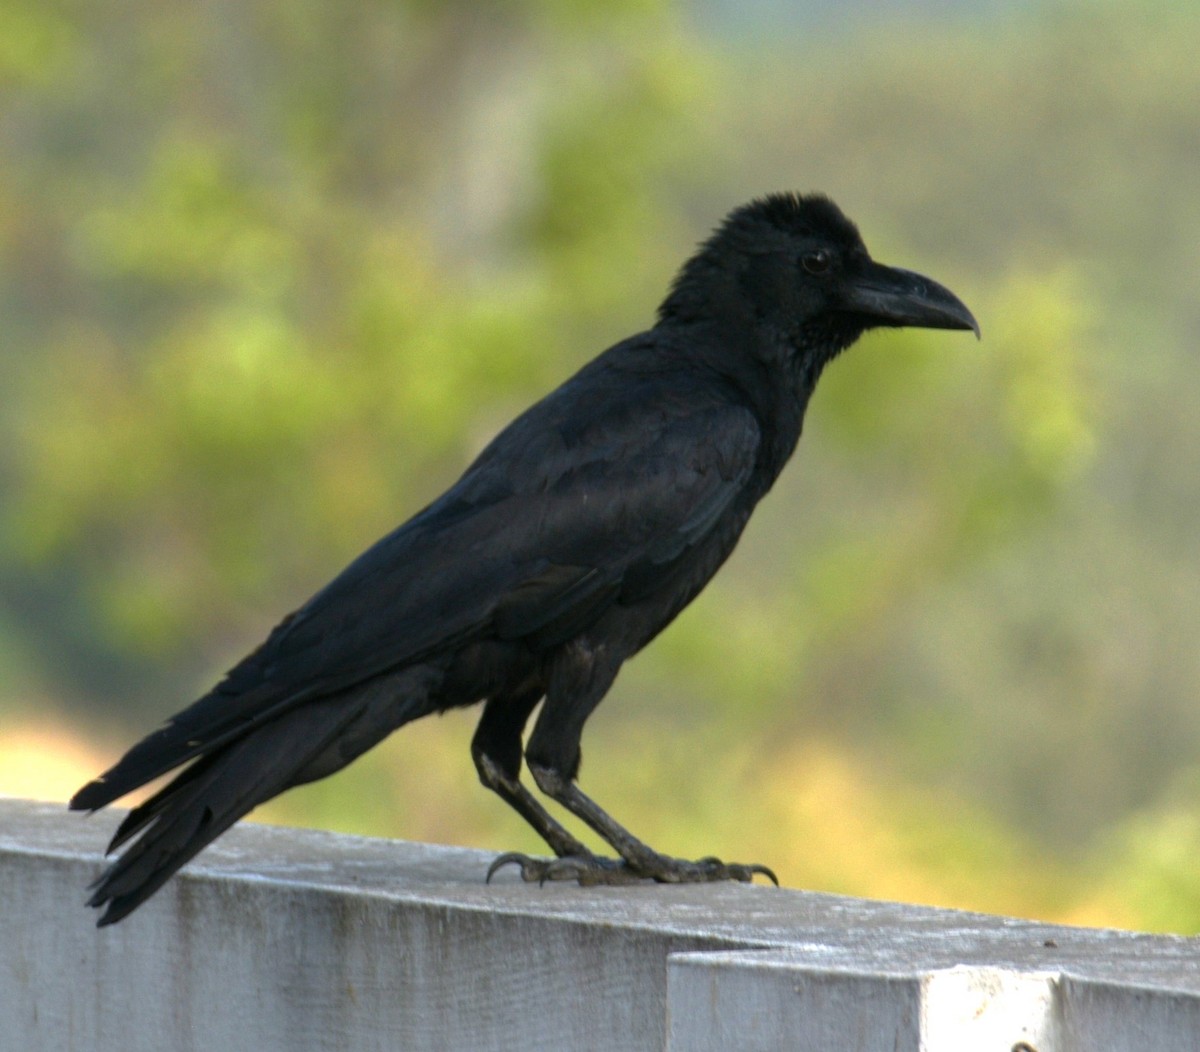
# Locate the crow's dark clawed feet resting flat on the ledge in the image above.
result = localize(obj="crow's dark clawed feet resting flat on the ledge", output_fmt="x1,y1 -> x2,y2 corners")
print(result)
487,852 -> 779,888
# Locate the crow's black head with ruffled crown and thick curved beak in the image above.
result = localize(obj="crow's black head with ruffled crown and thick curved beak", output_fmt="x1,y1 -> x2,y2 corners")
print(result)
659,193 -> 979,361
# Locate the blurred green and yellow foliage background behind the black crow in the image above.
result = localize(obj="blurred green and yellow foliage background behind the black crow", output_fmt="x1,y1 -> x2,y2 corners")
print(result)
0,0 -> 1200,932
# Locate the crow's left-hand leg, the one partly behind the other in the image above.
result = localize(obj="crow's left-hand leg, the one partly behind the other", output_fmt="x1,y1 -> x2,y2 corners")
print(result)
470,684 -> 589,880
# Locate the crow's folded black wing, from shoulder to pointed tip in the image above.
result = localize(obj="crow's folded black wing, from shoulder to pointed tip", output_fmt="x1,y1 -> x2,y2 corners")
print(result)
72,362 -> 760,808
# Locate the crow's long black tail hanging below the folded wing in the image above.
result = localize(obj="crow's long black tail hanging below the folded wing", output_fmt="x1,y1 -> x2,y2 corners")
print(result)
71,680 -> 431,927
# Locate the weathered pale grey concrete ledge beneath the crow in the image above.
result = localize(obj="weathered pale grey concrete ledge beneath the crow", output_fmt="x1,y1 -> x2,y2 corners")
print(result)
0,800 -> 1200,1052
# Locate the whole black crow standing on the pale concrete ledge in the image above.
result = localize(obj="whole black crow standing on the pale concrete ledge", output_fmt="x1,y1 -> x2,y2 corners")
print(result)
71,194 -> 979,925
